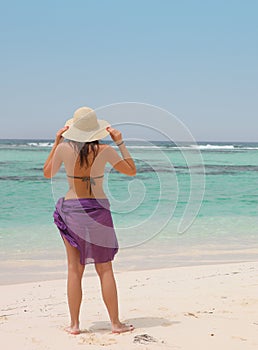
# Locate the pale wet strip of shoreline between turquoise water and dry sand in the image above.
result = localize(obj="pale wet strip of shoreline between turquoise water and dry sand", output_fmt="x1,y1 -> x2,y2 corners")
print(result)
0,241 -> 258,286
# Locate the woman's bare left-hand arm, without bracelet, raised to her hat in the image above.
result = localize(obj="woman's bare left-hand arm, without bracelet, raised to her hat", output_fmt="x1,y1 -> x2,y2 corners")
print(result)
43,126 -> 69,179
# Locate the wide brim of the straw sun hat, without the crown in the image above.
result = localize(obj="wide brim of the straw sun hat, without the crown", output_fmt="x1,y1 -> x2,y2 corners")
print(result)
62,119 -> 110,142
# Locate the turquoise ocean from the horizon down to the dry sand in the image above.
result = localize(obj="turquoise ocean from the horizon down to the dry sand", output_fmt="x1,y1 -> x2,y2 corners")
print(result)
0,140 -> 258,283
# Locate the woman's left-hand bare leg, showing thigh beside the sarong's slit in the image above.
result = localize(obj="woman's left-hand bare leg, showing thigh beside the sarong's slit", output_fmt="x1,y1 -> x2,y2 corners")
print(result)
64,238 -> 85,334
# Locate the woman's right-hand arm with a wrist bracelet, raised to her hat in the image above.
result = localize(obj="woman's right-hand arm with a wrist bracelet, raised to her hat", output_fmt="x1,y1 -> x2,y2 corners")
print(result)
107,127 -> 136,176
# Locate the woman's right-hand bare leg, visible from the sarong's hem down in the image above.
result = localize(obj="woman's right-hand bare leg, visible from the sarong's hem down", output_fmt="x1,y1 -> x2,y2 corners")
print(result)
95,261 -> 134,333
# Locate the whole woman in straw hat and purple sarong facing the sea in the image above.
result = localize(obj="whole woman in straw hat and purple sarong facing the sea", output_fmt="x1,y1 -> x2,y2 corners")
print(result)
44,107 -> 136,334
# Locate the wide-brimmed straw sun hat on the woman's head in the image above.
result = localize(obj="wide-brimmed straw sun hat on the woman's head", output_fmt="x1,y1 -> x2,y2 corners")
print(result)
62,107 -> 110,142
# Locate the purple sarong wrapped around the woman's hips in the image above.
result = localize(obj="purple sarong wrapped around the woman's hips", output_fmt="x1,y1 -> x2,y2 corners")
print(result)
53,198 -> 118,265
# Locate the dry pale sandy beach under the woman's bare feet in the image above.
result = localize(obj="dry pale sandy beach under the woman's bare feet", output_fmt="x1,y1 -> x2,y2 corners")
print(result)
0,262 -> 258,350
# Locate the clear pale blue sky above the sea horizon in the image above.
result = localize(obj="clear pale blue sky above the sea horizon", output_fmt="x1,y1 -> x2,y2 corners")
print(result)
0,0 -> 258,142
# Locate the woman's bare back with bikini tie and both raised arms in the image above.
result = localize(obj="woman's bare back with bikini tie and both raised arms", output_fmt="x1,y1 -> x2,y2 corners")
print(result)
44,127 -> 136,199
